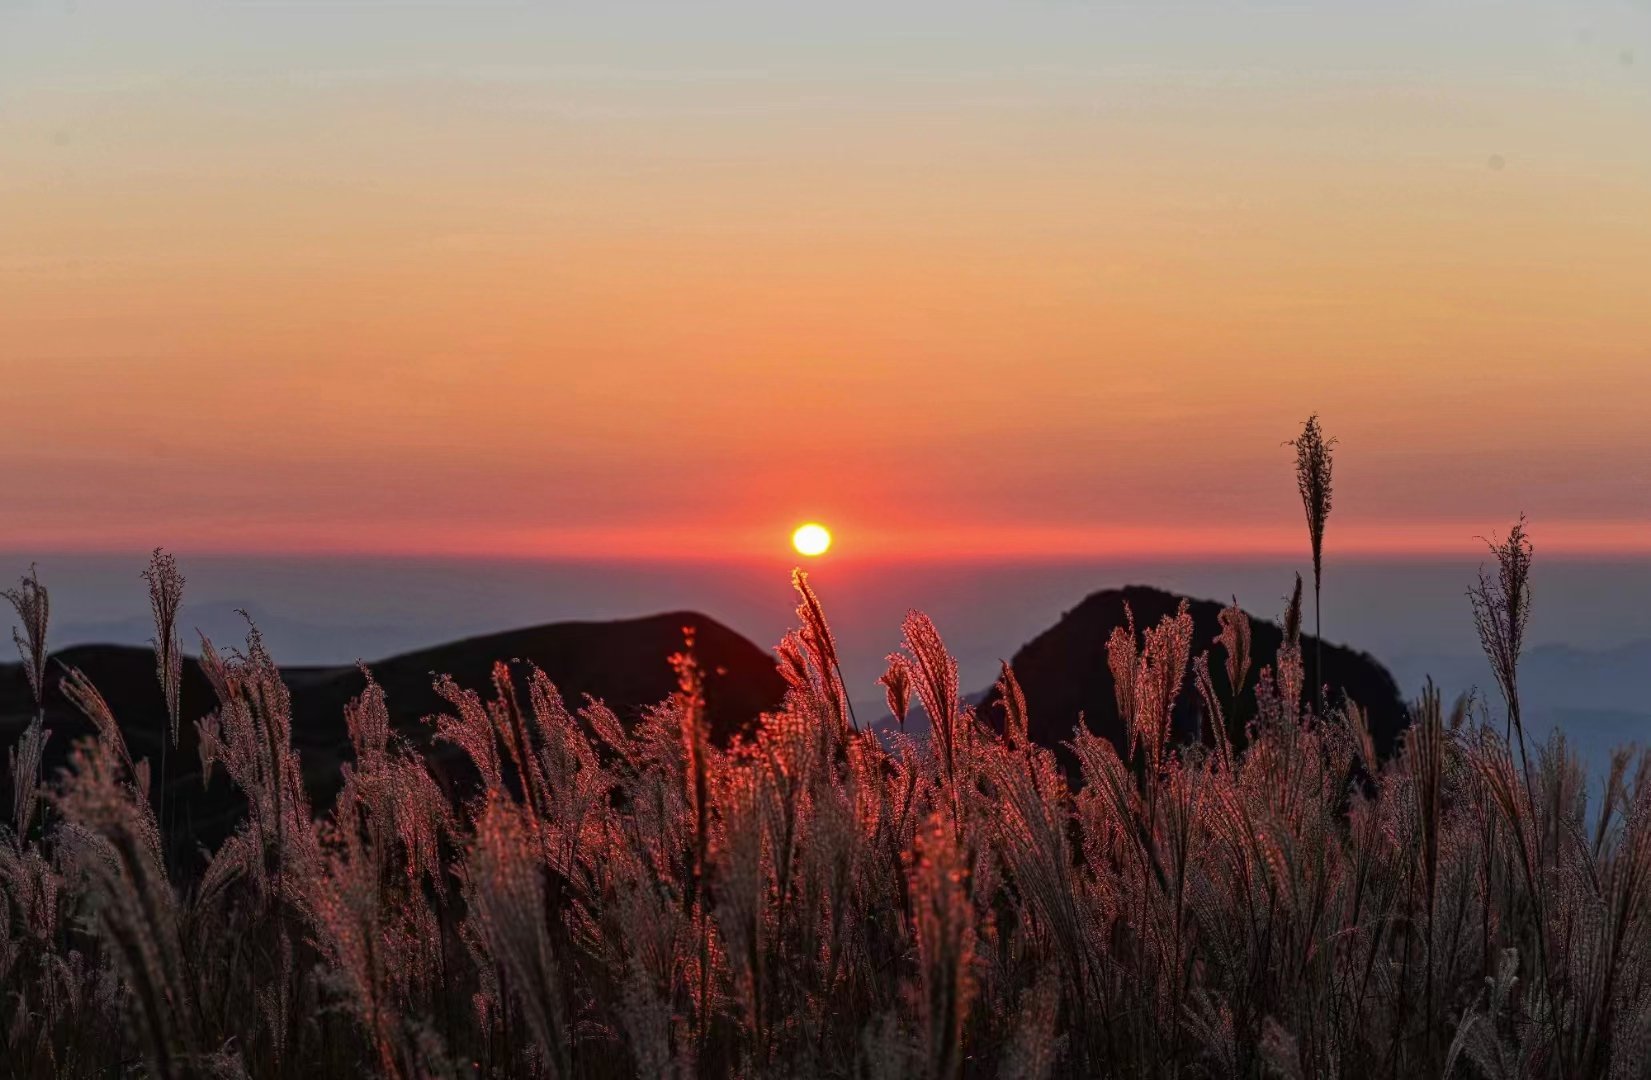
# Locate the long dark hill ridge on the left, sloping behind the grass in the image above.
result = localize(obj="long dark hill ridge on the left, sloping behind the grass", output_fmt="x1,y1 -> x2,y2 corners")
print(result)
0,611 -> 784,865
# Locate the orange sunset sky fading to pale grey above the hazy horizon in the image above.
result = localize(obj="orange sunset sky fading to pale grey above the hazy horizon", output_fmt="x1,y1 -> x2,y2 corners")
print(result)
0,0 -> 1651,568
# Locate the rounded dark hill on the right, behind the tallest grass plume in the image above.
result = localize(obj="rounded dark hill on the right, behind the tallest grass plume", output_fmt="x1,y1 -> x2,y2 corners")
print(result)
979,585 -> 1405,768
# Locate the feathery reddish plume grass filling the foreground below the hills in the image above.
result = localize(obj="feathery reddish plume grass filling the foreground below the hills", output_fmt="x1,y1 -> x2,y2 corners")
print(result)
0,426 -> 1651,1080
